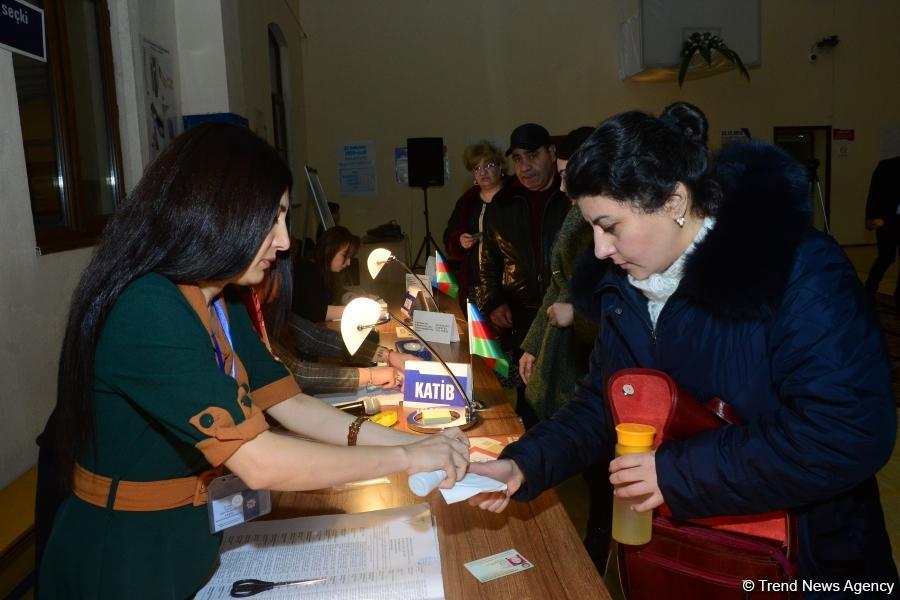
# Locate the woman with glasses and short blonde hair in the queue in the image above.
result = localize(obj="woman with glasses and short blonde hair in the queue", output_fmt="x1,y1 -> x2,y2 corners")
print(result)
444,142 -> 506,306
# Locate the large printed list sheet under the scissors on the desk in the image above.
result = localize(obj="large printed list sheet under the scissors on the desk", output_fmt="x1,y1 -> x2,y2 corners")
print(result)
196,504 -> 444,600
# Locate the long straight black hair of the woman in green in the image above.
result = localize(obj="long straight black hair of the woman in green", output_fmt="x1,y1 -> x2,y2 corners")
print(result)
55,123 -> 292,489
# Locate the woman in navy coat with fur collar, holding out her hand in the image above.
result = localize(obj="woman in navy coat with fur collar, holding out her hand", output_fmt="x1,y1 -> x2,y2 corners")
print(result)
470,112 -> 897,598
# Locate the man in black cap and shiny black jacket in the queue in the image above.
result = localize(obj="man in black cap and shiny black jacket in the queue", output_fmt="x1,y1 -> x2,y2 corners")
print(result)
475,123 -> 571,427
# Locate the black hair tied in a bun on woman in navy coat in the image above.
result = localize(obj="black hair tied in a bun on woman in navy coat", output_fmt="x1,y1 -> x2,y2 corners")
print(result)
566,110 -> 721,217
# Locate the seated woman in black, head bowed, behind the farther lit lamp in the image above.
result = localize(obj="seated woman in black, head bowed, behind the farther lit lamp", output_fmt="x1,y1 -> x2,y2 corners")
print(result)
292,225 -> 359,323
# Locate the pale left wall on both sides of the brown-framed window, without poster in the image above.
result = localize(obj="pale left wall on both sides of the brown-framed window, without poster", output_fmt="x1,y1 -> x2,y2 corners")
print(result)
0,0 -> 161,487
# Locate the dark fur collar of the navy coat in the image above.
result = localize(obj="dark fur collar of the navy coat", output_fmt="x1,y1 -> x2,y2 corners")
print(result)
571,142 -> 812,321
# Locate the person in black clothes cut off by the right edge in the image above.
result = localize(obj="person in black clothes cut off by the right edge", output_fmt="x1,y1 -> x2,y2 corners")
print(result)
866,156 -> 900,309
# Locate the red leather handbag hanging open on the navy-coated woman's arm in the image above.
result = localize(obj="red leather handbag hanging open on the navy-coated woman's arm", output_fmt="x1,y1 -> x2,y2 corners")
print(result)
607,369 -> 798,600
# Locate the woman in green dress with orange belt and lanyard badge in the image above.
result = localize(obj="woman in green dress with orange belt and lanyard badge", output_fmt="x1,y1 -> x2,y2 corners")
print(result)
37,123 -> 468,598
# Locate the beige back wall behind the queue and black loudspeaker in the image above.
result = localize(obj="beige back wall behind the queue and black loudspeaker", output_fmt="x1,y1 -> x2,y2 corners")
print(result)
302,0 -> 900,250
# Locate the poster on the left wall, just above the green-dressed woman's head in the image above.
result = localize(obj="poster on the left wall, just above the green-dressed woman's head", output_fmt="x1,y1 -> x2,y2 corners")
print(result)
141,38 -> 181,160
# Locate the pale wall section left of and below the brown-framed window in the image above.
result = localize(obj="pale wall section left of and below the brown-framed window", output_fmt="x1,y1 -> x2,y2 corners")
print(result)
0,55 -> 90,487
